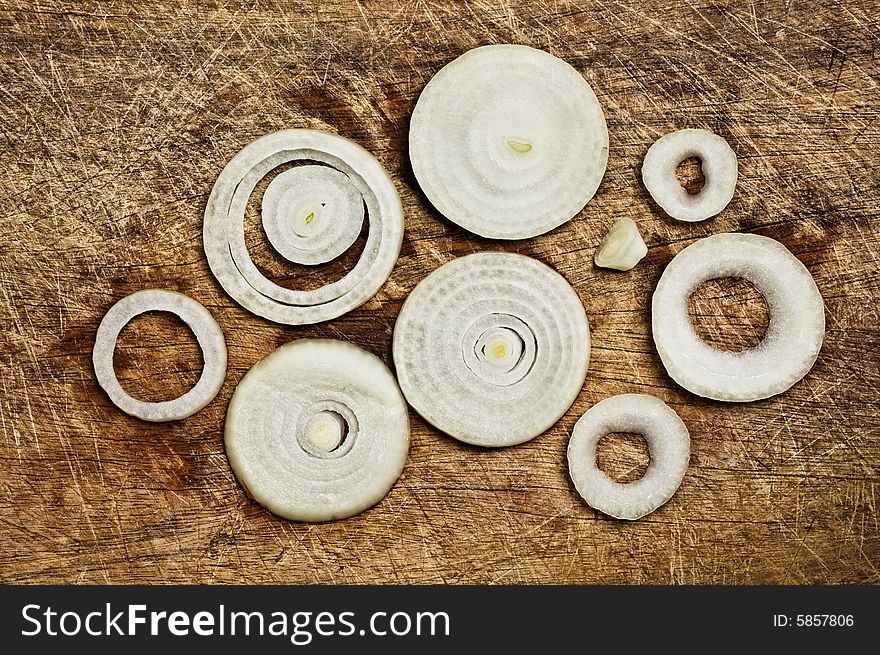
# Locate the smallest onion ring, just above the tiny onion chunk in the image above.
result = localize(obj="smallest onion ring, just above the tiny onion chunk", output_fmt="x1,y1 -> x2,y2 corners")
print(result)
642,129 -> 739,222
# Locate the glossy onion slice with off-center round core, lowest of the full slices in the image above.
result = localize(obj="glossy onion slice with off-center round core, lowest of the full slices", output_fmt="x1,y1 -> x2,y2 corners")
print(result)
225,339 -> 409,521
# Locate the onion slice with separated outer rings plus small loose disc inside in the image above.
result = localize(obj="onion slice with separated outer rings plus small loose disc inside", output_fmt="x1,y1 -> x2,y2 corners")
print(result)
203,130 -> 403,325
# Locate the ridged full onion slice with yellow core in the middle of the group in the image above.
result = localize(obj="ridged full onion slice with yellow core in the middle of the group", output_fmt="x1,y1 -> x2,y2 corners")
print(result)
393,252 -> 590,446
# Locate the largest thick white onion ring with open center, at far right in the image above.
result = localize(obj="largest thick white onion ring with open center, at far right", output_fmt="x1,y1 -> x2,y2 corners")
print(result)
651,233 -> 825,402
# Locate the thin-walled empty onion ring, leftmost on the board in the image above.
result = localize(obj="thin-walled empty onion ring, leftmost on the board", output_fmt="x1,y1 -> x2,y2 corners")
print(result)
92,289 -> 226,422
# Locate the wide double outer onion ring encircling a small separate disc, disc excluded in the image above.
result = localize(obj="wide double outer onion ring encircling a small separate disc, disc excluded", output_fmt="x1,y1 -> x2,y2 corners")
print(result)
203,130 -> 403,325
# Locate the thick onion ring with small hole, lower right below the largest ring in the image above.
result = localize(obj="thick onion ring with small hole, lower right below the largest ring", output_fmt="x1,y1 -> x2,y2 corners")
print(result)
568,394 -> 691,521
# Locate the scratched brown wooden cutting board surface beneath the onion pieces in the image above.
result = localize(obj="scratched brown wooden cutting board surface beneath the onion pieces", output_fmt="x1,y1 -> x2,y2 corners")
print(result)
0,0 -> 880,583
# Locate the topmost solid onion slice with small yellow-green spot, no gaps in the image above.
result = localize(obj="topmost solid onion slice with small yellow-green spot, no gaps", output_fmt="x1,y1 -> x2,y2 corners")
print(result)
409,45 -> 608,239
